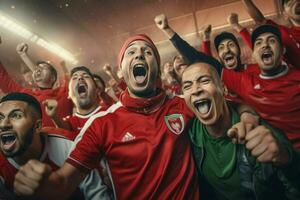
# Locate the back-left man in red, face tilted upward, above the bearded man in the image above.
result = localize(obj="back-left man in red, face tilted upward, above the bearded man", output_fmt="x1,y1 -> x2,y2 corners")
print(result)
0,40 -> 73,126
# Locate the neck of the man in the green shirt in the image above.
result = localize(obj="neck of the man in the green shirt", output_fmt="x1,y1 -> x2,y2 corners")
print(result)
206,102 -> 231,138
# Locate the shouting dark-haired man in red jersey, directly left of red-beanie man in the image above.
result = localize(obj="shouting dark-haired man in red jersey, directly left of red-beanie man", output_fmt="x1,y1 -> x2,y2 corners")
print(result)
44,66 -> 107,138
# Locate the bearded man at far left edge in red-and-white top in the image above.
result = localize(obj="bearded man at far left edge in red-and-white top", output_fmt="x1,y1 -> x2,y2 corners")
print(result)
0,93 -> 109,200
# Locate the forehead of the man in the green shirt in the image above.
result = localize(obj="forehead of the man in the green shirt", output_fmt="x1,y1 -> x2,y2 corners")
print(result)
182,63 -> 213,81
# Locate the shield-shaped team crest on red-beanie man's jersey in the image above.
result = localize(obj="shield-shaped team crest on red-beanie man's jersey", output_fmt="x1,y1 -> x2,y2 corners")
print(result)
165,114 -> 184,135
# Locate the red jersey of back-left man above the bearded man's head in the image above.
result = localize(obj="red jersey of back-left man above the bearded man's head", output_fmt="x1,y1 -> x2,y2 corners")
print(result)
0,63 -> 73,126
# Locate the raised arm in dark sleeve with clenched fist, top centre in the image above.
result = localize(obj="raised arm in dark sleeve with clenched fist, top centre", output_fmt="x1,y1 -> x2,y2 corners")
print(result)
154,14 -> 222,72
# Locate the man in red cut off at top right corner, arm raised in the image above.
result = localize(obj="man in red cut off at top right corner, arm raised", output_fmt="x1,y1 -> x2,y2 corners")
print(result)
241,0 -> 300,68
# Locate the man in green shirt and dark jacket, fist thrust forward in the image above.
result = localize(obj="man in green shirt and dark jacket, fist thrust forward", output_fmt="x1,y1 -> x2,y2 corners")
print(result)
182,62 -> 300,200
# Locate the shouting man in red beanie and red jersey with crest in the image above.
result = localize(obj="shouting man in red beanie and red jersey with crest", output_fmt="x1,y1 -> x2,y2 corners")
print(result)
15,35 -> 199,199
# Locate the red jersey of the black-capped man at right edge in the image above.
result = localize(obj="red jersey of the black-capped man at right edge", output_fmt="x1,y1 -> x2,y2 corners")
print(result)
222,66 -> 300,148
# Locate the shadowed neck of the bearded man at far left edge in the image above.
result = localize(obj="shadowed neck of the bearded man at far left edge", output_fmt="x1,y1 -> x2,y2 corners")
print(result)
13,133 -> 45,165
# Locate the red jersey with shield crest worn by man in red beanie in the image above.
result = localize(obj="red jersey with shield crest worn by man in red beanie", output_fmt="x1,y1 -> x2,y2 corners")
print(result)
67,93 -> 199,199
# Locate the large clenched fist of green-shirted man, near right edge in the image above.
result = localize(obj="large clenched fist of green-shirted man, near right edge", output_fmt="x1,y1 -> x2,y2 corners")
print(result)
245,125 -> 289,165
